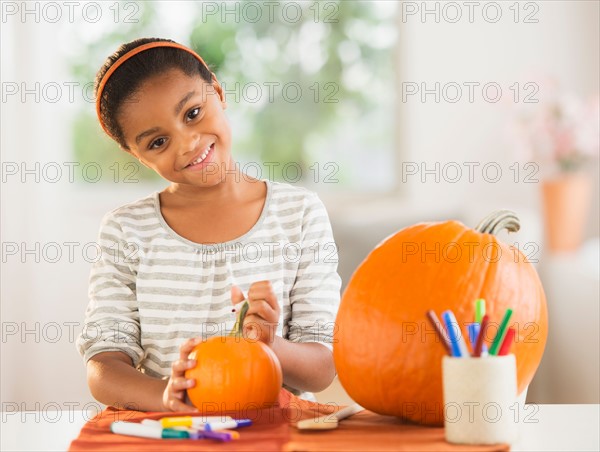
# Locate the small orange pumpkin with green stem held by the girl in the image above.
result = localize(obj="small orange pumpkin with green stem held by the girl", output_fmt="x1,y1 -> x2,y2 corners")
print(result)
185,303 -> 283,413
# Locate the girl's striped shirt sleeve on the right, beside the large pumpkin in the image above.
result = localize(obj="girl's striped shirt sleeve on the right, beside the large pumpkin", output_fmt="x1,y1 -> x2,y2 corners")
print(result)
288,193 -> 342,350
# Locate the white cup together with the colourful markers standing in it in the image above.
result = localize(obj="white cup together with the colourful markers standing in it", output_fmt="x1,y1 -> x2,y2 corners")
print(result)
427,299 -> 517,444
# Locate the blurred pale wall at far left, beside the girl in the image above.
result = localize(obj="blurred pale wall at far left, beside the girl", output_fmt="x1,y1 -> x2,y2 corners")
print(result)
1,16 -> 155,410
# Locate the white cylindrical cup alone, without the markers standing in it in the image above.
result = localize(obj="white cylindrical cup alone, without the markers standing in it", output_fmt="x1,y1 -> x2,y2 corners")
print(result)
442,355 -> 519,444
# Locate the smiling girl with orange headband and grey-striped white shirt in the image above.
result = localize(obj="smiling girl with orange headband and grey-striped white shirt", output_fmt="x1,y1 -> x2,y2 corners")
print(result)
77,39 -> 341,411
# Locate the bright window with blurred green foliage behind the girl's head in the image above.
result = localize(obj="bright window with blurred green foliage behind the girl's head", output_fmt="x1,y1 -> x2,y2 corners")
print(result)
69,1 -> 397,192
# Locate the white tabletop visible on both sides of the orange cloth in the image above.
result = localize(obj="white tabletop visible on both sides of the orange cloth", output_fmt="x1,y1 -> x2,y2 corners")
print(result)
0,405 -> 600,451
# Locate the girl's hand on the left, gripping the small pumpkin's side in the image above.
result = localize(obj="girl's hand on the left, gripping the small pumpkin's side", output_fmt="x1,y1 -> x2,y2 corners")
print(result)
163,337 -> 202,411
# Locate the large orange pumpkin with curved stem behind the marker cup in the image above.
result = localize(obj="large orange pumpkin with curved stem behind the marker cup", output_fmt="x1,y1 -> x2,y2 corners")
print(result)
334,211 -> 548,425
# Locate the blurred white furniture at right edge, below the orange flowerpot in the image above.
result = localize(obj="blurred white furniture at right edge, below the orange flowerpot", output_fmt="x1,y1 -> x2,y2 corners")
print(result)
528,239 -> 600,403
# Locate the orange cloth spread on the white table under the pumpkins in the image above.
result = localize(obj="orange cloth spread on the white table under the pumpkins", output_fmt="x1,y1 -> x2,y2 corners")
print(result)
69,390 -> 509,452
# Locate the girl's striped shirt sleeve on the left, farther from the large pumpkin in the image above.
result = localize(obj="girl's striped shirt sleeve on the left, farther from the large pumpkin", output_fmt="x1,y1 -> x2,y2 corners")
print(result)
76,213 -> 144,366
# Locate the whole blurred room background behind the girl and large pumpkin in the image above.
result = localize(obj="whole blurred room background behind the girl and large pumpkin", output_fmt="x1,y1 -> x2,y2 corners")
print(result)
0,1 -> 600,410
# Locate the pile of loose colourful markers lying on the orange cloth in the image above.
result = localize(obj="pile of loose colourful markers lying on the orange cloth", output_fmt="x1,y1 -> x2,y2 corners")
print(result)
110,416 -> 252,441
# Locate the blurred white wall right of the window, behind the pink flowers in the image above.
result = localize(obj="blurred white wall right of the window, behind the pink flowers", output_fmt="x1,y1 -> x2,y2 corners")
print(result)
400,1 -> 600,235
